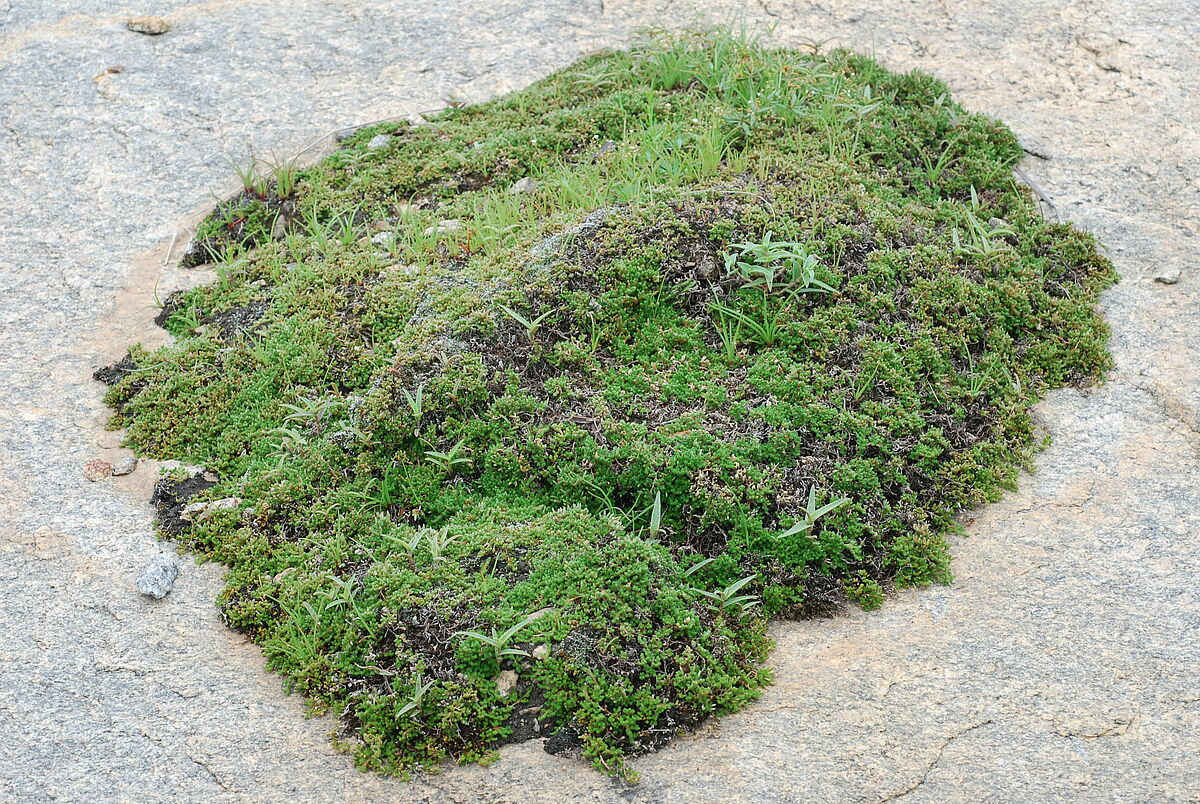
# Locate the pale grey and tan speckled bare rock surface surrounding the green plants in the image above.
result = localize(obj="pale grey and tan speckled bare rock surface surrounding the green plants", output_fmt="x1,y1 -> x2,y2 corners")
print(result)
0,0 -> 1200,804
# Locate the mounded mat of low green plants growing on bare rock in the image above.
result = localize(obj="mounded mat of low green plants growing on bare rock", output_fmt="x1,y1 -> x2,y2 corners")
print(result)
108,28 -> 1115,773
